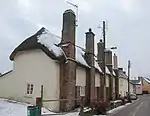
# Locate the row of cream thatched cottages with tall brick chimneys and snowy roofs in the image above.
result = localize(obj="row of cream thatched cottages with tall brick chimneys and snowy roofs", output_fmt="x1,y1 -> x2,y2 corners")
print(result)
0,10 -> 134,111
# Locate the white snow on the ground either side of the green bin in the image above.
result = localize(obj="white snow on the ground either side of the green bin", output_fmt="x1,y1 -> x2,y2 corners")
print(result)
0,99 -> 79,116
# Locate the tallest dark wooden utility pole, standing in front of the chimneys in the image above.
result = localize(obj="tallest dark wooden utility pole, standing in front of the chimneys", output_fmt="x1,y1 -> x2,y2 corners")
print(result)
103,21 -> 106,100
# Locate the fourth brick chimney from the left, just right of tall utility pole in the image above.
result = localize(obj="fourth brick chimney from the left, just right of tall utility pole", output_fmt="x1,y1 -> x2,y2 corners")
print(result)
105,50 -> 113,100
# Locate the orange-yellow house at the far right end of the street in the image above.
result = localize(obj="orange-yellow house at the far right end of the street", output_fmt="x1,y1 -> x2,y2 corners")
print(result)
141,77 -> 150,94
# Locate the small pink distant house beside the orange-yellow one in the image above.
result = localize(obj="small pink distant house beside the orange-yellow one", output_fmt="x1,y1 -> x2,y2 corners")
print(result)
131,77 -> 143,95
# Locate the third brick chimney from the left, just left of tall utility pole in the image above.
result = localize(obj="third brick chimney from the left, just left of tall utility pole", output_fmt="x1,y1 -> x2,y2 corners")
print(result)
97,40 -> 106,100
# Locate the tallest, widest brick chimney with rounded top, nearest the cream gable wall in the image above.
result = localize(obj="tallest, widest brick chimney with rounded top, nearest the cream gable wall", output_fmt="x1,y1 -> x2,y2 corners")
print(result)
60,9 -> 76,111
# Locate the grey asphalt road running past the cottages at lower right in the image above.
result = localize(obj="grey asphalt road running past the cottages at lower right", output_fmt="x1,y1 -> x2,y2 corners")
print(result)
110,95 -> 150,116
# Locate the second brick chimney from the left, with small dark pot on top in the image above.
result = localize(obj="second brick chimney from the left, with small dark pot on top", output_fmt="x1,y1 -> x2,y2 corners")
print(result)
85,29 -> 95,102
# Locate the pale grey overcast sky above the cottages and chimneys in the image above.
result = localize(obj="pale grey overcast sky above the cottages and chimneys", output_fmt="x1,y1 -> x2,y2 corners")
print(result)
0,0 -> 150,76
